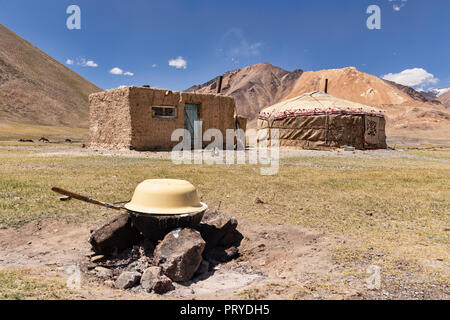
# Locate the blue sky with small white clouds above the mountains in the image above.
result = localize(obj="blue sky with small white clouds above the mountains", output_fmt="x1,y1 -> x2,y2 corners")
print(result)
0,0 -> 450,90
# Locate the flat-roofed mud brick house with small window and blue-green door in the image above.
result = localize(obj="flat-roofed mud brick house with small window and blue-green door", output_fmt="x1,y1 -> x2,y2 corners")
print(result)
89,87 -> 245,151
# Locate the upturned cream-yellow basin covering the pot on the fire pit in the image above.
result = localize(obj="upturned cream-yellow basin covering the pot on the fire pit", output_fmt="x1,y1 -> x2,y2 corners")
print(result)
125,179 -> 208,215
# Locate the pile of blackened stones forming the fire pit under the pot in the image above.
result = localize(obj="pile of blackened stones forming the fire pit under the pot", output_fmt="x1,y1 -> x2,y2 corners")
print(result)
87,210 -> 243,294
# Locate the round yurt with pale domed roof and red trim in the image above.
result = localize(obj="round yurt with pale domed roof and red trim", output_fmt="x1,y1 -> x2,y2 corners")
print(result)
258,91 -> 386,149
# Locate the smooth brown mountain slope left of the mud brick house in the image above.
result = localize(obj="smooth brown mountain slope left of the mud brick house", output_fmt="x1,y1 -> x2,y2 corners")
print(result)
0,25 -> 102,128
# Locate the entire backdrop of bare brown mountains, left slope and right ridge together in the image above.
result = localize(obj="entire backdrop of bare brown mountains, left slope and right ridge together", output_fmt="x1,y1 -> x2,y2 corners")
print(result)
0,25 -> 450,142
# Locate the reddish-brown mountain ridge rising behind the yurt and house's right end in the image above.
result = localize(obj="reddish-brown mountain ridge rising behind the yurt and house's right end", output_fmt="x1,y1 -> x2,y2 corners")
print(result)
188,64 -> 450,142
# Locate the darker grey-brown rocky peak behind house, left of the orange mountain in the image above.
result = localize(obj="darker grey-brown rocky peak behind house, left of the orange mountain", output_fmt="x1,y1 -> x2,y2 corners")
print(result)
186,63 -> 303,119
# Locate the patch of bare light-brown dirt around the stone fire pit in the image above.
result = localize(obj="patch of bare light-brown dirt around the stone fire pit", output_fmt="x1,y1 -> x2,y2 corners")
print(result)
0,221 -> 336,299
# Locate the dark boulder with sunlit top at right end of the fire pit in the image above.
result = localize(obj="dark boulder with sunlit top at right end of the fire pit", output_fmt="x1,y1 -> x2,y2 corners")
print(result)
197,210 -> 243,252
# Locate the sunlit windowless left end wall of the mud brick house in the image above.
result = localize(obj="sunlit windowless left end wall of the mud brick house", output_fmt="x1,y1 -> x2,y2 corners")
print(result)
89,88 -> 131,149
